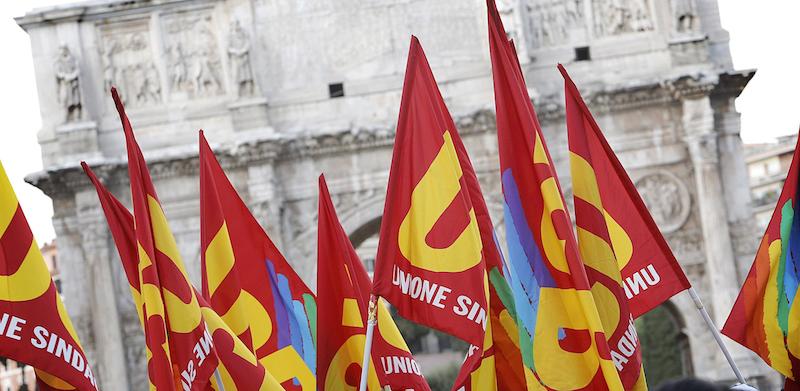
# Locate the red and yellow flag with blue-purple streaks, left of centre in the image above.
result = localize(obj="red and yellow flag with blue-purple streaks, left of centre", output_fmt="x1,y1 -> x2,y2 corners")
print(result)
200,132 -> 317,391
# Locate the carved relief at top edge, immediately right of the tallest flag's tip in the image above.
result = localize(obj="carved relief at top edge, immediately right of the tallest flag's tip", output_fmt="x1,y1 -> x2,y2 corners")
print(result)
526,0 -> 585,47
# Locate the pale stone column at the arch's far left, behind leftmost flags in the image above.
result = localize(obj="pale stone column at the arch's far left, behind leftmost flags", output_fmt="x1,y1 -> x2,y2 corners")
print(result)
76,189 -> 129,391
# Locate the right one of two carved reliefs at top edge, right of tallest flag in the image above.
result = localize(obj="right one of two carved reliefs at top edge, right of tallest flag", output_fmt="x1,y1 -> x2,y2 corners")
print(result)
592,0 -> 653,37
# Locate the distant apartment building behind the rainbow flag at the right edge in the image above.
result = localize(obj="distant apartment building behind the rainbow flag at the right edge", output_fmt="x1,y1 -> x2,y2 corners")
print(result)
744,135 -> 797,231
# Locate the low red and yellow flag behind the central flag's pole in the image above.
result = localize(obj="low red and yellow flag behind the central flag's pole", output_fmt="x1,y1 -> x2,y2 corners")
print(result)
317,175 -> 430,391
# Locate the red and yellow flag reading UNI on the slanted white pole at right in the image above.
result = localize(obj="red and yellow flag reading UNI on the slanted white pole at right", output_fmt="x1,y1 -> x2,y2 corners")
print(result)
559,65 -> 648,390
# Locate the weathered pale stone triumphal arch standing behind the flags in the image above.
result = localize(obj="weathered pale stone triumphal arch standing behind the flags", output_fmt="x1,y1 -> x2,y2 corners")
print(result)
17,0 -> 777,391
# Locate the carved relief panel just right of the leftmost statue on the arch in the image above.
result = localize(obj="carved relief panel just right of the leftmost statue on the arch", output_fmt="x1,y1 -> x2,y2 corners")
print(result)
100,21 -> 162,106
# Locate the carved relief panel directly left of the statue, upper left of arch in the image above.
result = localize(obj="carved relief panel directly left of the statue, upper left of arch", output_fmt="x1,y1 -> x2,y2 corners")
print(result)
163,12 -> 224,98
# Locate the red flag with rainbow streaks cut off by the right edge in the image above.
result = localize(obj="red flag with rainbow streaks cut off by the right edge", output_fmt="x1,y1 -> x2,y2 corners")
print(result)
722,132 -> 800,382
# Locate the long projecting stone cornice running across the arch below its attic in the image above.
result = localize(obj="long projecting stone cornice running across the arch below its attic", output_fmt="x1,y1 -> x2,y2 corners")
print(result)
27,71 -> 753,197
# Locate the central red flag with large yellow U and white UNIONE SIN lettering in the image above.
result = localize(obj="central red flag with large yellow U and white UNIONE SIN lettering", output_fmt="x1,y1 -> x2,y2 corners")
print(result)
373,37 -> 488,346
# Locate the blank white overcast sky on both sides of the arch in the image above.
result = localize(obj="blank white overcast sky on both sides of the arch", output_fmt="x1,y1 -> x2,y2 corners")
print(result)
0,0 -> 800,244
